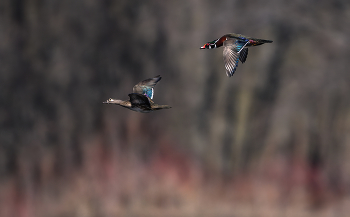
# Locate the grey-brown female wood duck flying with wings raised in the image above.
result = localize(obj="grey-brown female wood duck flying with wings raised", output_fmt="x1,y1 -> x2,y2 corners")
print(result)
103,75 -> 171,113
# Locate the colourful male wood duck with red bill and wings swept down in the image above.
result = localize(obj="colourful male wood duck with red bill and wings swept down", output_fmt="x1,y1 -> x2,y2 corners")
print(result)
200,33 -> 272,77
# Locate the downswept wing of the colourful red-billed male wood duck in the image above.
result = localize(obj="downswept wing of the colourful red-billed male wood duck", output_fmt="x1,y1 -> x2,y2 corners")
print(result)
223,39 -> 249,77
